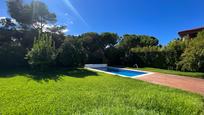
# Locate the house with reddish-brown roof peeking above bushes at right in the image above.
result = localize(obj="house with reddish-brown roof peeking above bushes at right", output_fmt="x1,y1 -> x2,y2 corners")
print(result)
178,27 -> 204,39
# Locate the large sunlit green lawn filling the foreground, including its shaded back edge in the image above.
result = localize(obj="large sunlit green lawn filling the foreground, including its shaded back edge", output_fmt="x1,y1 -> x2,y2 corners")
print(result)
0,69 -> 204,115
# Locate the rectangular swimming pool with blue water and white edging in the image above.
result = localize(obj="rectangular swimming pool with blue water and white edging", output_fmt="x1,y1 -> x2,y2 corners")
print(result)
85,66 -> 150,78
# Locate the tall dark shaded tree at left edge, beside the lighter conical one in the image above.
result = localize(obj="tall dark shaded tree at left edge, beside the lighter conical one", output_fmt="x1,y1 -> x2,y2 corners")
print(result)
0,18 -> 26,68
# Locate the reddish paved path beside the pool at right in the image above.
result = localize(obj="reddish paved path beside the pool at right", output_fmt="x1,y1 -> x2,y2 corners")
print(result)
137,73 -> 204,95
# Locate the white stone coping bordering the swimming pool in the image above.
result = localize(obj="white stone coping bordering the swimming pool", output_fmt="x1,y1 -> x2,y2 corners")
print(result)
84,66 -> 154,79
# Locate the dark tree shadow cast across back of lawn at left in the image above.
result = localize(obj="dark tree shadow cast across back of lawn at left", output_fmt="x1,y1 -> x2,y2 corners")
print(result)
0,68 -> 98,81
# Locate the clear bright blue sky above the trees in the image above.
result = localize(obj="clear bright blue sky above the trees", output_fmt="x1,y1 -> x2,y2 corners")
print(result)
0,0 -> 204,45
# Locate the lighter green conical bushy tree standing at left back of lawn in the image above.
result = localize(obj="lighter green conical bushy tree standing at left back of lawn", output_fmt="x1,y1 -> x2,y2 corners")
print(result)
26,33 -> 57,70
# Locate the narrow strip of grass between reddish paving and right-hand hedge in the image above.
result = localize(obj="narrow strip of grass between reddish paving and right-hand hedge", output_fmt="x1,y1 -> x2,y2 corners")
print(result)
132,67 -> 204,78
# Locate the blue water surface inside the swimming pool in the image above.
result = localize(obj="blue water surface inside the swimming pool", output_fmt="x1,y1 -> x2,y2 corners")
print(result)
94,67 -> 147,77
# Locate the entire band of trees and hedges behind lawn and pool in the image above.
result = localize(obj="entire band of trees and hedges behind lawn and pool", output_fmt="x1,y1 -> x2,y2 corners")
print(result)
0,0 -> 204,71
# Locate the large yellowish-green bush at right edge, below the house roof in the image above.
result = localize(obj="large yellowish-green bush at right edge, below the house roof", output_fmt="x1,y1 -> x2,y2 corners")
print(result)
177,31 -> 204,72
